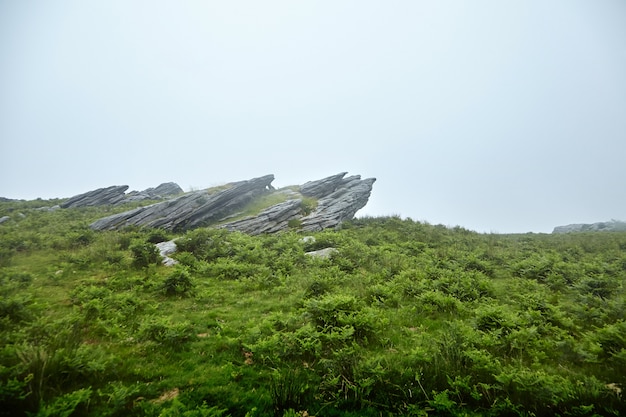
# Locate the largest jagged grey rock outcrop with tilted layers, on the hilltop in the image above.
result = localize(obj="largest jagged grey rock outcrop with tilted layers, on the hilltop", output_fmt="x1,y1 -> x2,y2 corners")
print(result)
91,173 -> 376,235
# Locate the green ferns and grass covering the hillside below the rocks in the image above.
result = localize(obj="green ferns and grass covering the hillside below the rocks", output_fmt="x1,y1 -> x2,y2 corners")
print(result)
0,201 -> 626,417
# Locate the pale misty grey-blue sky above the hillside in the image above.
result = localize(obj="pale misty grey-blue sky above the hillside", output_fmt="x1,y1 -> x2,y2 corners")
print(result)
0,0 -> 626,233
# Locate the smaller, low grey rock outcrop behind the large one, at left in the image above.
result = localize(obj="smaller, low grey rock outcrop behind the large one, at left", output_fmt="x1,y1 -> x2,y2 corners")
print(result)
61,182 -> 183,208
